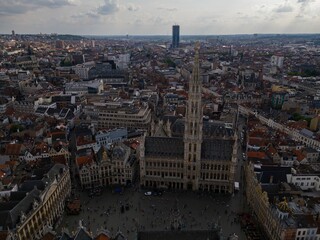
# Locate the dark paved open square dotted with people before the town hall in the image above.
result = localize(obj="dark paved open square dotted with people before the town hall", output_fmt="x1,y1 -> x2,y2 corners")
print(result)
60,188 -> 245,240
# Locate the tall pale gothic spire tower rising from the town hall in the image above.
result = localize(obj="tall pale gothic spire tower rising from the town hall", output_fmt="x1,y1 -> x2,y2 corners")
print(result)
183,43 -> 203,190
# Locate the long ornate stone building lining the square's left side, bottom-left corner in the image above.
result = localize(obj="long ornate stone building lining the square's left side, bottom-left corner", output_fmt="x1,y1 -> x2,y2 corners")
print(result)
3,164 -> 71,240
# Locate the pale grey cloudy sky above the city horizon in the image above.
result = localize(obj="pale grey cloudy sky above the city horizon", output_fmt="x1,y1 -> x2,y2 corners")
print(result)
0,0 -> 320,35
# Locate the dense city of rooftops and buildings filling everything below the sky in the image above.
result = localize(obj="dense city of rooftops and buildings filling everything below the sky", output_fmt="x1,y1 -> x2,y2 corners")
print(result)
0,19 -> 320,240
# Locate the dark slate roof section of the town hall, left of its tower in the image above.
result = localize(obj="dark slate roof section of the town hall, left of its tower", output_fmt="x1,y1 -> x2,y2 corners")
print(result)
145,137 -> 184,159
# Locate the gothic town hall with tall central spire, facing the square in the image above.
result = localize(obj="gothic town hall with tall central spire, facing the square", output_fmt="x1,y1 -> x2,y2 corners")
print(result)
140,44 -> 238,193
